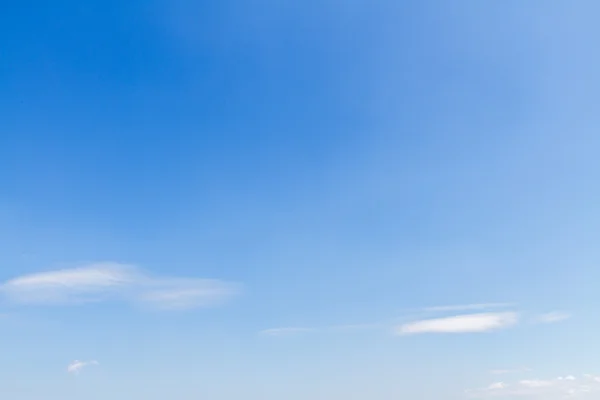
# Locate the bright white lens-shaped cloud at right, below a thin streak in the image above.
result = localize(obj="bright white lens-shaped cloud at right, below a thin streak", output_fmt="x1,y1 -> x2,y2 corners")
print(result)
396,312 -> 518,335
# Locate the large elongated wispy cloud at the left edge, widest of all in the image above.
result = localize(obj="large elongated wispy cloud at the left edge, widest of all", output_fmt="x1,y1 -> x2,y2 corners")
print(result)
0,263 -> 239,309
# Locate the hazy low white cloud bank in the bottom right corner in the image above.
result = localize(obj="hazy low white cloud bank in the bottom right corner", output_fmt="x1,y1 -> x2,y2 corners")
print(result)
466,374 -> 600,400
